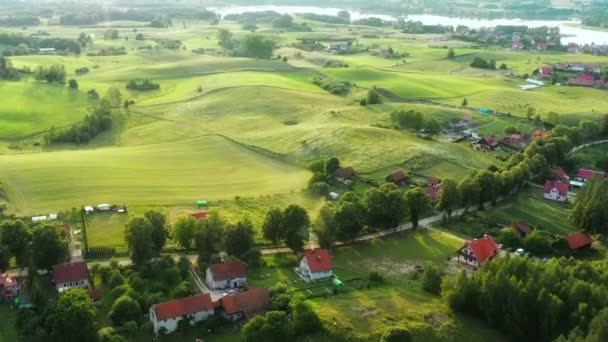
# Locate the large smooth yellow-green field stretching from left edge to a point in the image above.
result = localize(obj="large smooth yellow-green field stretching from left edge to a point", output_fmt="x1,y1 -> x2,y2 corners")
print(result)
0,135 -> 310,214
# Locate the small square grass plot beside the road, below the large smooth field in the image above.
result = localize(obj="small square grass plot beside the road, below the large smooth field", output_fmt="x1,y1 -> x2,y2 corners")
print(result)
87,213 -> 129,248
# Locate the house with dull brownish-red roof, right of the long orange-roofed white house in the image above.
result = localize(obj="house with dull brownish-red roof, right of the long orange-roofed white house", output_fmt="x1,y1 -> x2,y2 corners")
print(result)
220,287 -> 270,321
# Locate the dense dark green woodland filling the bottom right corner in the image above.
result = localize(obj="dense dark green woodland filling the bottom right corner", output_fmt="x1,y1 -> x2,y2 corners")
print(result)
442,257 -> 608,342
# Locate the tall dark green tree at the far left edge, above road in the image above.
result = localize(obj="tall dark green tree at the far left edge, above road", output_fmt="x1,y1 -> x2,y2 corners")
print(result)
0,220 -> 32,268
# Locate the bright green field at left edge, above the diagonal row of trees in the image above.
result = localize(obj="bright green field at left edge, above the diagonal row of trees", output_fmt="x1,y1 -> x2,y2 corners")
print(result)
0,82 -> 91,138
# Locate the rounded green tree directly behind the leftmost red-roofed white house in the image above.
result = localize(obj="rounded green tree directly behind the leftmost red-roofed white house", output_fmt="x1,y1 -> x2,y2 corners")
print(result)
31,223 -> 70,270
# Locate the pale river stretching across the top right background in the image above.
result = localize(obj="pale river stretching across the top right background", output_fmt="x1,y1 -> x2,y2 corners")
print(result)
209,5 -> 608,45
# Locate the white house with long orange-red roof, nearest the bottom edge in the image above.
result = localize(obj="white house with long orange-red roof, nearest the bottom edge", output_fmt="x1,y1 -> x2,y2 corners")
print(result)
150,293 -> 215,336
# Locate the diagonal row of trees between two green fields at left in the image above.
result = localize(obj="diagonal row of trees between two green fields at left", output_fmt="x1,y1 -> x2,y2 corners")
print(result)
46,100 -> 112,144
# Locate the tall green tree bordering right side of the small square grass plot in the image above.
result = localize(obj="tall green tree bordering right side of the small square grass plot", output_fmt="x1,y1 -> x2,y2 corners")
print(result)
125,217 -> 156,267
